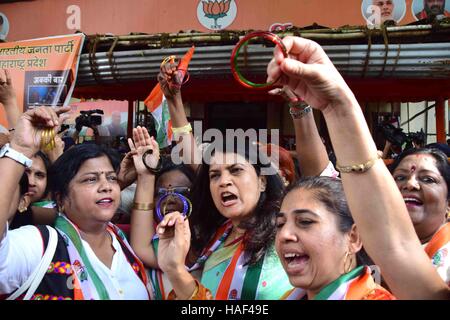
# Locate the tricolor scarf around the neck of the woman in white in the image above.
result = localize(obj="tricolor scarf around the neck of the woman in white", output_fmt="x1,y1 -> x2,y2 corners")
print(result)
55,214 -> 148,300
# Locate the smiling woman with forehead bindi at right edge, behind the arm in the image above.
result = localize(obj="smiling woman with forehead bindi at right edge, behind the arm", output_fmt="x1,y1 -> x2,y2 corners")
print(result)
390,148 -> 450,285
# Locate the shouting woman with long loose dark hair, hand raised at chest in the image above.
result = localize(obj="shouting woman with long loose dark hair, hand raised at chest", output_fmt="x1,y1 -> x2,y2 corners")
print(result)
157,140 -> 292,300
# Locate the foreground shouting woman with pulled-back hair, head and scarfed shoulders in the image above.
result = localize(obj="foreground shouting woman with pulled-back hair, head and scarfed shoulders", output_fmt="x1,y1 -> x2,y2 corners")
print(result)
275,177 -> 394,300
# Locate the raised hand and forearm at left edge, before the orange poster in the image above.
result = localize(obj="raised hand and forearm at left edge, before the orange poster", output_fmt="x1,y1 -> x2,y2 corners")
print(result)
0,70 -> 21,128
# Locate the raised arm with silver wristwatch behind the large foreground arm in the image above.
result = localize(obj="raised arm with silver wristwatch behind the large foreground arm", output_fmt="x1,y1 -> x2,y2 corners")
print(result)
270,86 -> 329,177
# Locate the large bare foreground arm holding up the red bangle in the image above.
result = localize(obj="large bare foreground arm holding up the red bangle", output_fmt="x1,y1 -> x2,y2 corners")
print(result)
268,37 -> 450,299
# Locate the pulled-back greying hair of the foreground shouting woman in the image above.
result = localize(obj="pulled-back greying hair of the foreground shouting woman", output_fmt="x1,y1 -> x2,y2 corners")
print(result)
283,177 -> 372,265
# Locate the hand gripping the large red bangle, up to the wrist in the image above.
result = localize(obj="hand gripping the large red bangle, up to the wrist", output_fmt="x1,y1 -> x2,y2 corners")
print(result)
267,36 -> 354,112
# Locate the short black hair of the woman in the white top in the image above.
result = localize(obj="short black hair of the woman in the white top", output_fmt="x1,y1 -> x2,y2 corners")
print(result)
47,144 -> 120,201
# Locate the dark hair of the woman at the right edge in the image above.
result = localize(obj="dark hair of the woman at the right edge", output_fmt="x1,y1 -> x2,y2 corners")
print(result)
389,148 -> 450,200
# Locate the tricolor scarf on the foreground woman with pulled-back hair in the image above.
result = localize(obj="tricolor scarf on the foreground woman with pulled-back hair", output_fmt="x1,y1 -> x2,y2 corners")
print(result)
281,266 -> 395,300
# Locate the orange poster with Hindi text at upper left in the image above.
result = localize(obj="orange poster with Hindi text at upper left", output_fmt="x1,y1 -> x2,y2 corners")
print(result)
0,34 -> 84,127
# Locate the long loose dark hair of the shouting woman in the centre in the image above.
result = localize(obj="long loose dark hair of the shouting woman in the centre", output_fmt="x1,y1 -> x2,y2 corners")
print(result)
190,143 -> 284,265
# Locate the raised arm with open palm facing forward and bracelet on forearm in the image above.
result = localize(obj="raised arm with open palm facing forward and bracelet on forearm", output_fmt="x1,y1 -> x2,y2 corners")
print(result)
128,126 -> 159,268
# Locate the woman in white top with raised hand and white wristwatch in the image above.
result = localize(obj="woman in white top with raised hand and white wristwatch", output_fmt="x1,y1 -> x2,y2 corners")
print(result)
0,107 -> 154,300
